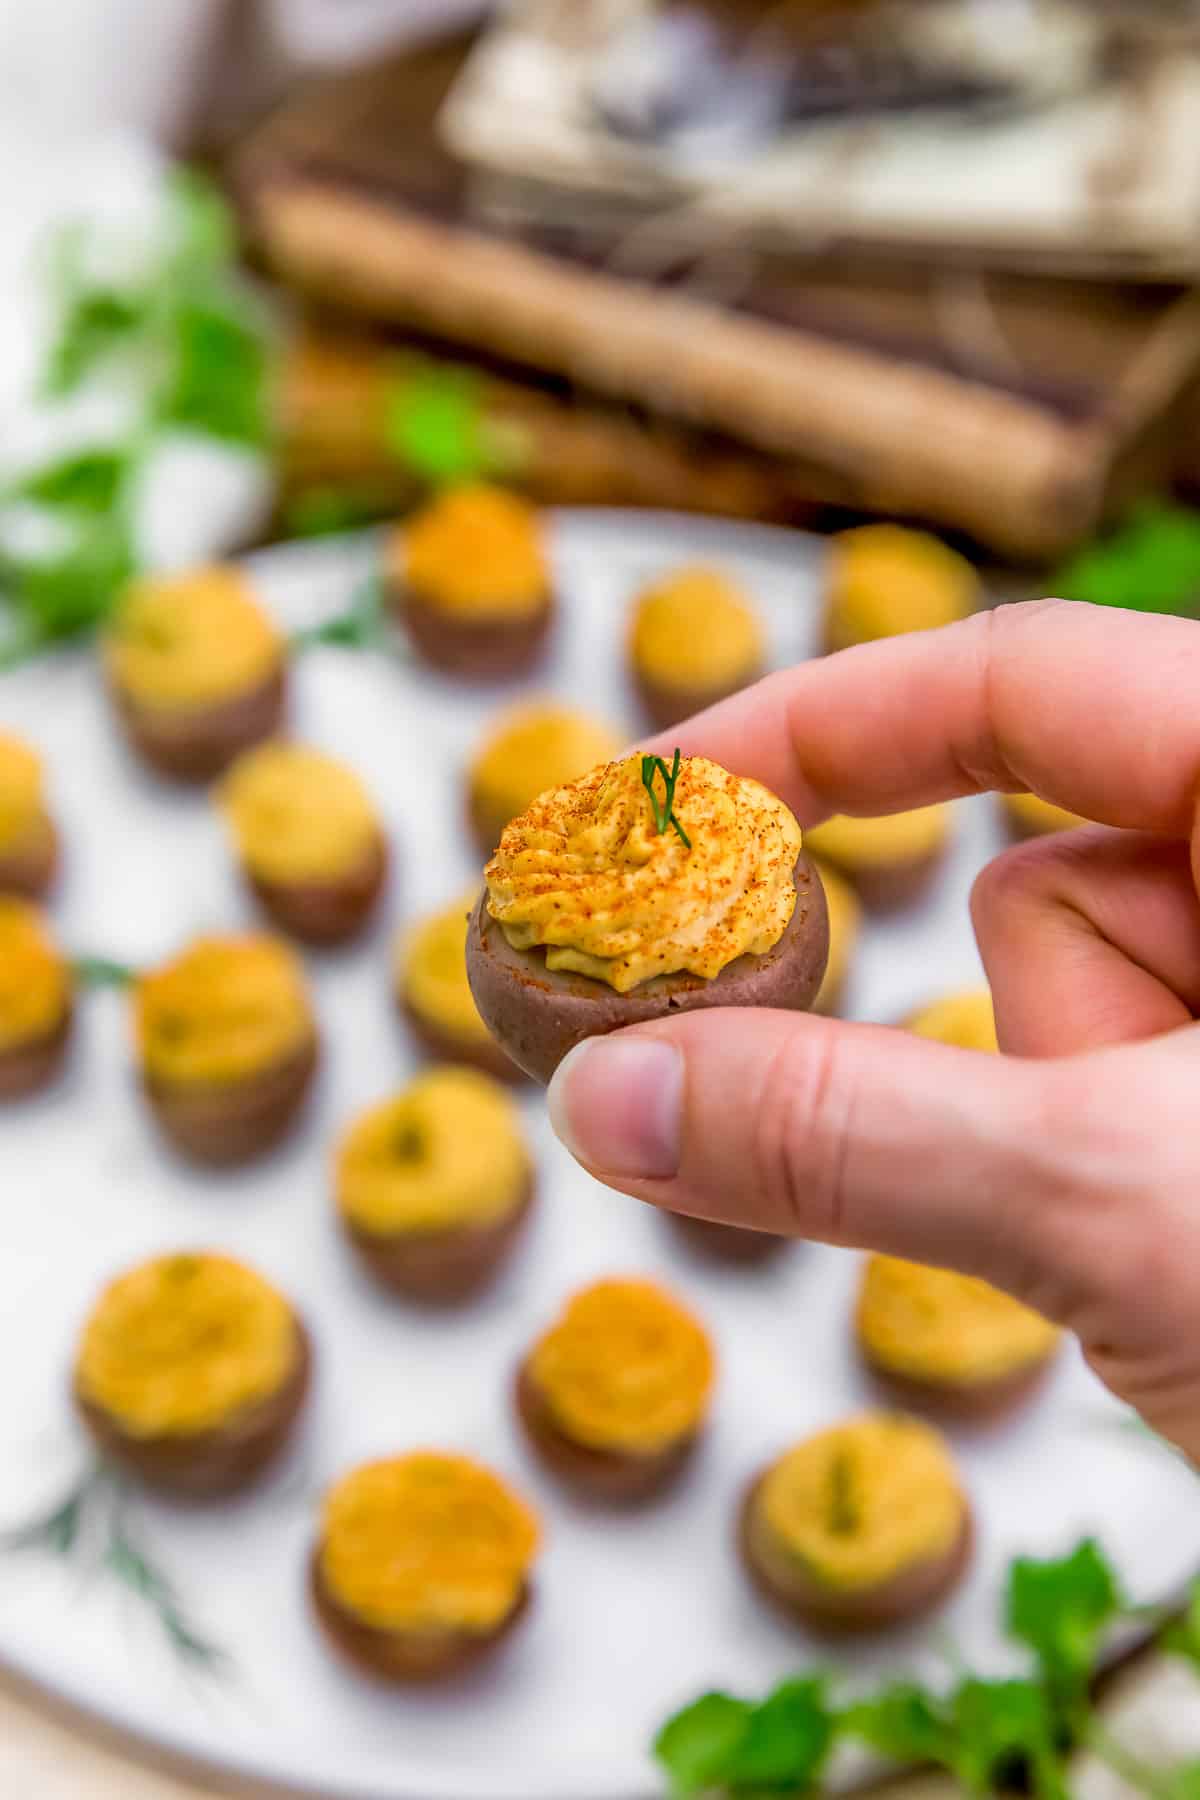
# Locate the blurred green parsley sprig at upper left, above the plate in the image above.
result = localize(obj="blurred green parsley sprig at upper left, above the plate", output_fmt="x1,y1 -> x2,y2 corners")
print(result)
0,169 -> 273,668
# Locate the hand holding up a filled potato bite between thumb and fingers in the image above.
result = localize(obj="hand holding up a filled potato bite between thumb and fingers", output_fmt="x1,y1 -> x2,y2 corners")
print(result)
551,601 -> 1200,1462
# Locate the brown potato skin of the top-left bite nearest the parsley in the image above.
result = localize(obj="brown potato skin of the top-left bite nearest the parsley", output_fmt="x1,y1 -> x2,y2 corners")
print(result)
110,666 -> 288,783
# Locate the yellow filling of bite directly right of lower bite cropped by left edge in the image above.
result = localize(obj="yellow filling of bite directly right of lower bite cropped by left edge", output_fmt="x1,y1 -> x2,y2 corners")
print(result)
133,934 -> 313,1085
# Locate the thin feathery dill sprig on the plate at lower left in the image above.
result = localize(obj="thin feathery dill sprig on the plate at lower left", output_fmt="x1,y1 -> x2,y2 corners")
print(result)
0,1462 -> 232,1676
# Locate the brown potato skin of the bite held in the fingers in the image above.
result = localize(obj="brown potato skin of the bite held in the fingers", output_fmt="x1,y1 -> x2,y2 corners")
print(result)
466,855 -> 829,1082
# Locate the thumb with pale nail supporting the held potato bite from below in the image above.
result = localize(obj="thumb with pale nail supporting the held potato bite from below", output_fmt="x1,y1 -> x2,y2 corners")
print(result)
549,1008 -> 1103,1319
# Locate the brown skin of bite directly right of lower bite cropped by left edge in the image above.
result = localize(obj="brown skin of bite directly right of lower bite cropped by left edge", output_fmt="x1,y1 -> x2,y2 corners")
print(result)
142,1037 -> 320,1168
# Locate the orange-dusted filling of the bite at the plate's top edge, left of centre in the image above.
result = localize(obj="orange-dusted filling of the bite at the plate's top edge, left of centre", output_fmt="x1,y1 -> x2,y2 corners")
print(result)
390,486 -> 551,623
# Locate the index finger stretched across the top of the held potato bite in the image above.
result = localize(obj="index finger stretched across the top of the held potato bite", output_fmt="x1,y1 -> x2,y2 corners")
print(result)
647,599 -> 1200,837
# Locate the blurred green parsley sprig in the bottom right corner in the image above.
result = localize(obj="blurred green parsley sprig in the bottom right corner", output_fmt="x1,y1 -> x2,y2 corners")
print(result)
653,1539 -> 1200,1800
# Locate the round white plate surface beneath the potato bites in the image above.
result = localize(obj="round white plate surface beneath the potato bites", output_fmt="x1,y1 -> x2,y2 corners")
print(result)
0,513 -> 1200,1800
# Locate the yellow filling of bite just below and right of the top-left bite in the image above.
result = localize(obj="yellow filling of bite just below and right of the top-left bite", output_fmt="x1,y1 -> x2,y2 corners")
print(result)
221,743 -> 380,884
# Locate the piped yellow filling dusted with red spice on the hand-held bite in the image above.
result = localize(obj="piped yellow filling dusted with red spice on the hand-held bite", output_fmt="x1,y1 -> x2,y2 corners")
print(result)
486,756 -> 801,994
